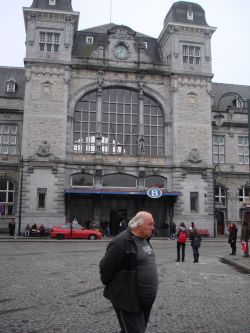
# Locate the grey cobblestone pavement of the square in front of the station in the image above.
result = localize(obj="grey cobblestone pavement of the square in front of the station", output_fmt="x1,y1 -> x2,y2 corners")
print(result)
0,240 -> 250,333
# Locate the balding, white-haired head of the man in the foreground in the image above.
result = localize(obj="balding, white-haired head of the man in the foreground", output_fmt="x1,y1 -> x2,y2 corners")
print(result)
128,211 -> 155,238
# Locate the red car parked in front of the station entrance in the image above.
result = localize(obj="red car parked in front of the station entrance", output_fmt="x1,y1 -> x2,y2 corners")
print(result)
50,223 -> 102,239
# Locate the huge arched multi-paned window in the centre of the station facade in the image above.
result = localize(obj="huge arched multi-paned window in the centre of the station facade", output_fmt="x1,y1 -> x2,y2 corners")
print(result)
73,88 -> 164,156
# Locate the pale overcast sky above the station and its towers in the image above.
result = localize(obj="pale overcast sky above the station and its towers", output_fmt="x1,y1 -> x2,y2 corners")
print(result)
0,0 -> 250,85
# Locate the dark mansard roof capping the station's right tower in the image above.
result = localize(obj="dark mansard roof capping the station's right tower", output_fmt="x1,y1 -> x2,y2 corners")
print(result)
164,1 -> 209,27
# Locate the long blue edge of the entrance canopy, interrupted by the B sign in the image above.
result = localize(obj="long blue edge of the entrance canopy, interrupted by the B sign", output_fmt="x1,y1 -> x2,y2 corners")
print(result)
64,188 -> 182,197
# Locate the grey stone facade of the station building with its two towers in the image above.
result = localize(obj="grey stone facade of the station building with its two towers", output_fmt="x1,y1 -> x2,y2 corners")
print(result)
0,0 -> 250,236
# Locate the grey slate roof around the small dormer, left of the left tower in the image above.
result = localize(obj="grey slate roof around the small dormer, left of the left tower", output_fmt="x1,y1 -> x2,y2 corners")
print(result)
0,67 -> 25,98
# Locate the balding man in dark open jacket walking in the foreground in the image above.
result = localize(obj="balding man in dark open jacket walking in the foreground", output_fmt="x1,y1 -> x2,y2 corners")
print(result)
100,211 -> 158,333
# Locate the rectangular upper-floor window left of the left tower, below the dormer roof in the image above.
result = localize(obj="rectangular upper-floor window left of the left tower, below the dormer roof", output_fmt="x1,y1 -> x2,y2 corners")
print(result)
0,123 -> 17,155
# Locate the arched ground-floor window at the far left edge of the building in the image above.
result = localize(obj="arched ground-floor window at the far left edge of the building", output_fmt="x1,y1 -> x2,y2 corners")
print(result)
0,178 -> 15,216
